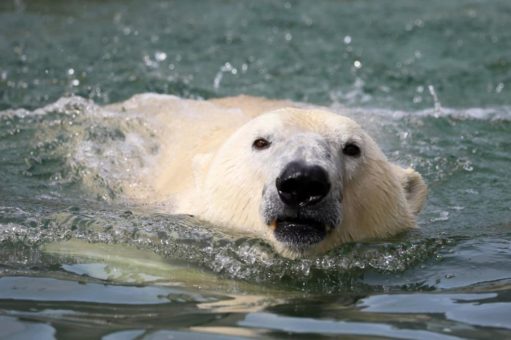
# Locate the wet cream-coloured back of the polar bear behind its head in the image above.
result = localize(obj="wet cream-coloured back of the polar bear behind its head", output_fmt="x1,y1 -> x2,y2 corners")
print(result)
104,93 -> 299,210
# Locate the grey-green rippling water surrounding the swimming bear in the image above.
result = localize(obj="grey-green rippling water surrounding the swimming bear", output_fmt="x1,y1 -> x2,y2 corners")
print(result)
0,0 -> 511,339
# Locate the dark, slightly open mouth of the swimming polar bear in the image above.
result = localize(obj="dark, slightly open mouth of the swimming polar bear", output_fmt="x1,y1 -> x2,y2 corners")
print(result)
272,217 -> 327,247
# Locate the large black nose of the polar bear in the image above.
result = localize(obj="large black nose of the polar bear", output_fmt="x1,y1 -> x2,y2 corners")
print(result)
275,162 -> 330,207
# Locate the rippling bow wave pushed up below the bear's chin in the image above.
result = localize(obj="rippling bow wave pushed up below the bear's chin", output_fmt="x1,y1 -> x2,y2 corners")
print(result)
0,203 -> 449,291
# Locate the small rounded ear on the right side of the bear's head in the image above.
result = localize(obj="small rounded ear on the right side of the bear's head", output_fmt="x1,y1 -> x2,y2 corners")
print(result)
394,165 -> 428,215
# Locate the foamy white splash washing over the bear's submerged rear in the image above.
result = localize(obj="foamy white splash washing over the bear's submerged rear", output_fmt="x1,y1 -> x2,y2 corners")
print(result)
0,97 -> 158,200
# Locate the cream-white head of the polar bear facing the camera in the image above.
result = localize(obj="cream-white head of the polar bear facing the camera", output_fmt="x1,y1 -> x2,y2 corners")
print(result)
196,108 -> 427,258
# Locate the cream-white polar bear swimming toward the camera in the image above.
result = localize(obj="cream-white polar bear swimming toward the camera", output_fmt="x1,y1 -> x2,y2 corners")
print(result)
107,94 -> 427,258
